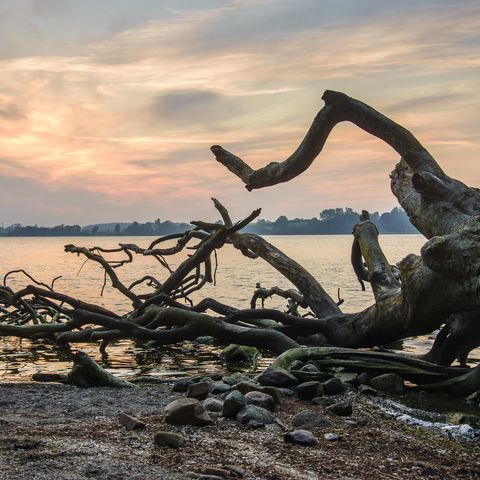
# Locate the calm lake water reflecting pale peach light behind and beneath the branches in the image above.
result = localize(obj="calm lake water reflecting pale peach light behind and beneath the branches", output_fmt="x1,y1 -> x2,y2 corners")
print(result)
0,235 -> 480,380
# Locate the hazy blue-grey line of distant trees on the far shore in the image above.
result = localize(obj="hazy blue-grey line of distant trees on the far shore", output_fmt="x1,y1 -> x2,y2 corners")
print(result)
0,207 -> 418,237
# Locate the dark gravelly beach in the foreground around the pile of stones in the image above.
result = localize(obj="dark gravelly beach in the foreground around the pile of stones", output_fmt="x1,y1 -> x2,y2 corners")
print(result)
0,382 -> 480,480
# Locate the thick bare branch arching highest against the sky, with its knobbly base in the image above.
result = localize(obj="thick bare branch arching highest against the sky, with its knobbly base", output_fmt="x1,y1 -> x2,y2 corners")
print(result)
215,90 -> 480,238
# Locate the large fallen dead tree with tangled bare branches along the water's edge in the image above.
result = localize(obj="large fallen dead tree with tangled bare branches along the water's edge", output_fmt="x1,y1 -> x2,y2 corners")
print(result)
0,91 -> 480,394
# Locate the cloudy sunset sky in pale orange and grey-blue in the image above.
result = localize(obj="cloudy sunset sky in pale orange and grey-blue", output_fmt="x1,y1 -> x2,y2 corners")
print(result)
0,0 -> 480,226
